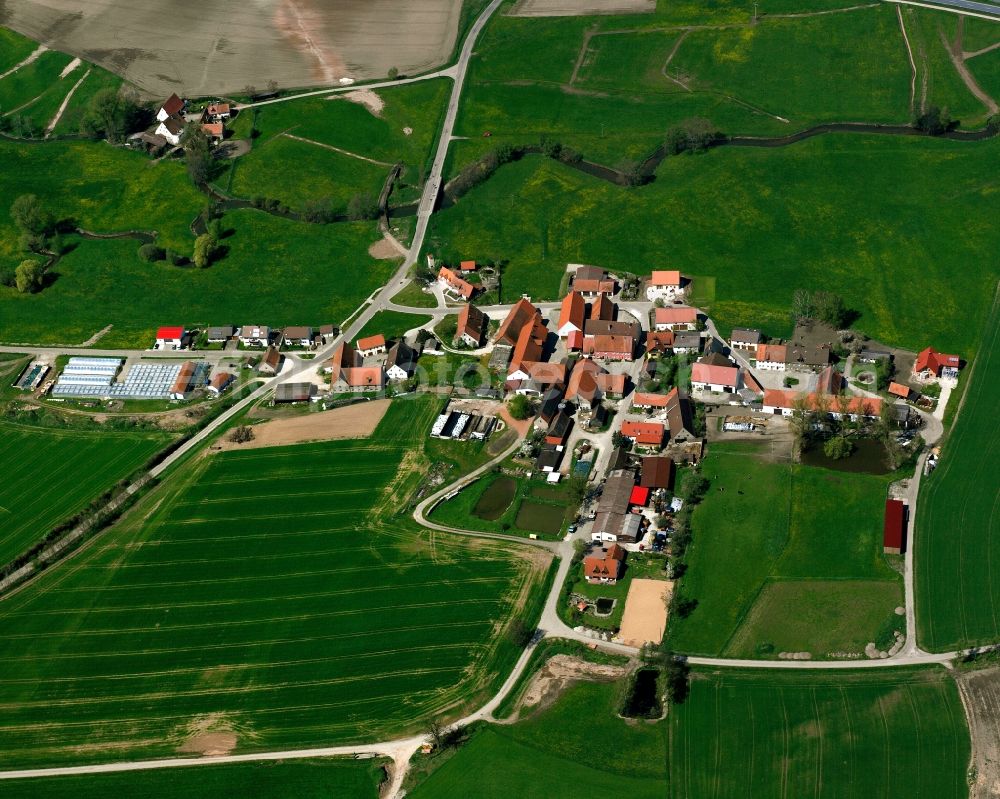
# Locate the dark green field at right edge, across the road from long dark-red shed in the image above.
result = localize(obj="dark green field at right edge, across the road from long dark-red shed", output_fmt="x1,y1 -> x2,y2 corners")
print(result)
914,296 -> 1000,651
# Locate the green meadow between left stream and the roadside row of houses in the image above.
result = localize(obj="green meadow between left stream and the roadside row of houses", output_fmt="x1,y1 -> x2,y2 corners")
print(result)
0,209 -> 394,347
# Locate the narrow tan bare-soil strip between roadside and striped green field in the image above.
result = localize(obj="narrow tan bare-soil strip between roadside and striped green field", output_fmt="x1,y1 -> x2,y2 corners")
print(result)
219,400 -> 390,449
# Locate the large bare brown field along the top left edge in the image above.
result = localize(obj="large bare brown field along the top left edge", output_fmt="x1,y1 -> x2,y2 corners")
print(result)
0,0 -> 462,97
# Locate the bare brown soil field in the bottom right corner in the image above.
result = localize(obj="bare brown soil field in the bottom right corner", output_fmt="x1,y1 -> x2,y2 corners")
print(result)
957,667 -> 1000,799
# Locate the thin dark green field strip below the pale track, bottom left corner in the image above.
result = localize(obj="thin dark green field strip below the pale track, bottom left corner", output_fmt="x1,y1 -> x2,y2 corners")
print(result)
3,758 -> 384,799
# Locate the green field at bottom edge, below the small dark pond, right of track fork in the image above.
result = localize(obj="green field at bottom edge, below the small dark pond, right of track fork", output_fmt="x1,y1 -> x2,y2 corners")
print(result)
407,682 -> 667,799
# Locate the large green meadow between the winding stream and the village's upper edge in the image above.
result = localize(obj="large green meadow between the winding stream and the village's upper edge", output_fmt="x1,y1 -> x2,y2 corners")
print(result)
427,134 -> 1000,353
